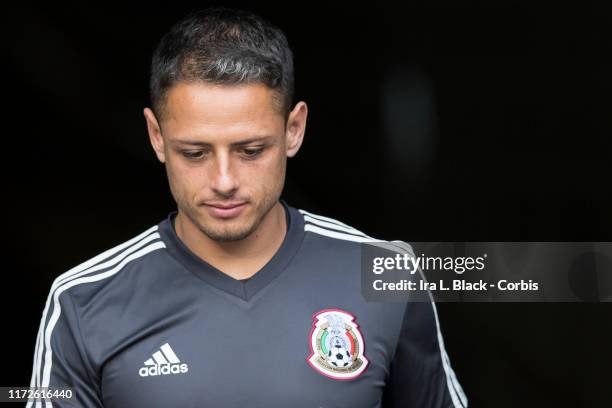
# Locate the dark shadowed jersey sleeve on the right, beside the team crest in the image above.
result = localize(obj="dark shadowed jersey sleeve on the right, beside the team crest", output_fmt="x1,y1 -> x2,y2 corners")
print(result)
382,300 -> 467,408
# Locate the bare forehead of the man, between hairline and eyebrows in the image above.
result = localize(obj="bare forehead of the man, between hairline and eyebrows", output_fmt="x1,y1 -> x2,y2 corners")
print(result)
162,82 -> 284,142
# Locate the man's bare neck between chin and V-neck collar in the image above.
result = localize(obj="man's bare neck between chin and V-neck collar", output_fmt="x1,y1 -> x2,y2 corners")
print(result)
175,202 -> 287,279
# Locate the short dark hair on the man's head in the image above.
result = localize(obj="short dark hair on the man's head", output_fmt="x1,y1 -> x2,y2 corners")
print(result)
149,7 -> 294,118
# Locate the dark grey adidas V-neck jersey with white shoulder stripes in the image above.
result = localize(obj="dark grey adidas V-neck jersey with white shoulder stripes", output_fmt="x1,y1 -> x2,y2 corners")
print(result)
28,203 -> 467,408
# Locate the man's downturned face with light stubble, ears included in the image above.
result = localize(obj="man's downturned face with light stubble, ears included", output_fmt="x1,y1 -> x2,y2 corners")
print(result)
145,82 -> 306,242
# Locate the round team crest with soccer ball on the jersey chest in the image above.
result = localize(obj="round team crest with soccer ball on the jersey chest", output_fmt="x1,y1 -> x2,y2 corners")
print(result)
308,309 -> 368,380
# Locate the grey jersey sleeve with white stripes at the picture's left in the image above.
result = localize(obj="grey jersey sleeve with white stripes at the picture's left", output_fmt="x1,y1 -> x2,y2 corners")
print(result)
27,292 -> 103,408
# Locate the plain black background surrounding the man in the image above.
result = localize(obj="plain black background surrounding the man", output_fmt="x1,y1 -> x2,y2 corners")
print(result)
0,1 -> 612,408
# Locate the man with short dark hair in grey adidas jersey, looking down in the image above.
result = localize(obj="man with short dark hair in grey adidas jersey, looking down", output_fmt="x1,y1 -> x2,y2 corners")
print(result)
29,9 -> 467,408
